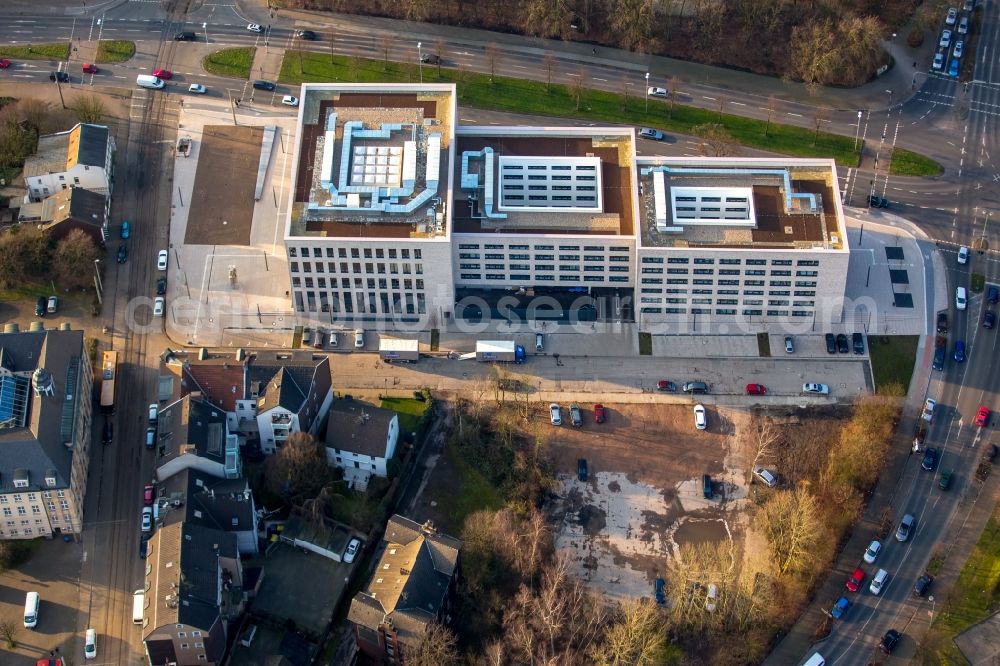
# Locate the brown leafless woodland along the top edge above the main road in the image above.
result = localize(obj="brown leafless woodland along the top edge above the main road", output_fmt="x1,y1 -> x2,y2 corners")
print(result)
284,0 -> 904,87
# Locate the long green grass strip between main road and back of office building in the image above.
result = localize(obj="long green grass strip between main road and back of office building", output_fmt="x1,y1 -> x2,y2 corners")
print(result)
279,51 -> 936,166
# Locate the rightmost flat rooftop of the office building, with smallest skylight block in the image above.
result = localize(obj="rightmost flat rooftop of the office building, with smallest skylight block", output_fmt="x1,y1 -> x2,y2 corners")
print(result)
636,158 -> 846,250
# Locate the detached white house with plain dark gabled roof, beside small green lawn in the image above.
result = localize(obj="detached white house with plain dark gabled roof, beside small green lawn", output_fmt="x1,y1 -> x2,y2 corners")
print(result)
326,400 -> 399,489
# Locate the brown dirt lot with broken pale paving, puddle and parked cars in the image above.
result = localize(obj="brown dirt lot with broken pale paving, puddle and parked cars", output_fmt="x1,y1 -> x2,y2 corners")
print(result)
546,404 -> 746,598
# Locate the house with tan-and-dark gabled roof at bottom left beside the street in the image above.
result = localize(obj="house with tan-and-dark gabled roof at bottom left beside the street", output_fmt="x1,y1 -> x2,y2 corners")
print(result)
142,522 -> 246,666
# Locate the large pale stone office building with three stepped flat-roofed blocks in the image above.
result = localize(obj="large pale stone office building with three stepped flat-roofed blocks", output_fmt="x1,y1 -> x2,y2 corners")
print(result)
285,84 -> 849,328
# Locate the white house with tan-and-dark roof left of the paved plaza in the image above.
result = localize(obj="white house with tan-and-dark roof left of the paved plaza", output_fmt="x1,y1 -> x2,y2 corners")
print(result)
24,123 -> 115,201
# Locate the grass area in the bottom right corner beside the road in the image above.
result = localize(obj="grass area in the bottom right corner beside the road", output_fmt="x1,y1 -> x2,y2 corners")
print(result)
924,505 -> 1000,664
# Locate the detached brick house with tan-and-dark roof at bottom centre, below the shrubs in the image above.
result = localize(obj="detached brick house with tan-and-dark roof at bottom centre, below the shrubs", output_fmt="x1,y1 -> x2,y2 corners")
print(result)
347,515 -> 462,664
